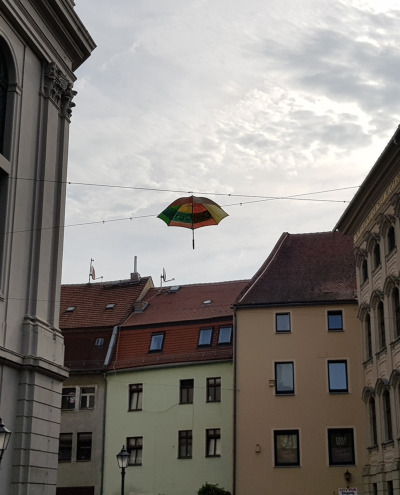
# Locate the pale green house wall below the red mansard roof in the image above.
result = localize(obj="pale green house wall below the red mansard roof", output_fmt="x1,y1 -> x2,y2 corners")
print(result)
104,362 -> 233,495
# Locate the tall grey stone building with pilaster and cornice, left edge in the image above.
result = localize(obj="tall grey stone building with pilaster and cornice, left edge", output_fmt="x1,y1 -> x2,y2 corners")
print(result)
0,0 -> 94,495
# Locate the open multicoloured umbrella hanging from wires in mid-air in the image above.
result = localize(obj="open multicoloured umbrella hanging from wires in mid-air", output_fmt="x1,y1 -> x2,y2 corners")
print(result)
158,196 -> 228,249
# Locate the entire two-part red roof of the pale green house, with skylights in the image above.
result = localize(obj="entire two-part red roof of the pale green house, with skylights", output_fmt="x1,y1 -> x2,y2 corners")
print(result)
110,280 -> 249,369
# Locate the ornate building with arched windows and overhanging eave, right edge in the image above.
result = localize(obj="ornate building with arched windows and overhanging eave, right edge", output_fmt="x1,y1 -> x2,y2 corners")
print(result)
336,131 -> 400,495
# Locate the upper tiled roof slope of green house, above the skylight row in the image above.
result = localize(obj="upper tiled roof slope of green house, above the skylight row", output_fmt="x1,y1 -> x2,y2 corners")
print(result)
123,280 -> 249,327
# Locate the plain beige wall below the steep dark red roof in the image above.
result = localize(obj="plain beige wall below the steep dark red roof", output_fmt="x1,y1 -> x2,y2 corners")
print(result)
235,304 -> 365,495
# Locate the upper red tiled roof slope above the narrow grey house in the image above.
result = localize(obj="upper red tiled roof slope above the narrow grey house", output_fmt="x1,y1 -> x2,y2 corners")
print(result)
60,277 -> 153,330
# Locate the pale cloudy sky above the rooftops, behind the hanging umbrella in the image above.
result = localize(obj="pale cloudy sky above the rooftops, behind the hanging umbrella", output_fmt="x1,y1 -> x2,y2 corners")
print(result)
63,0 -> 400,285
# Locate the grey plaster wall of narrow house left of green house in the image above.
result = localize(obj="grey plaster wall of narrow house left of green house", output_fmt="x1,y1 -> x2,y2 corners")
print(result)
57,373 -> 106,495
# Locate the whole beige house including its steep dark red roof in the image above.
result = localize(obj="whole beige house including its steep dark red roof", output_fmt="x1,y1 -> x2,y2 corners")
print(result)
234,233 -> 366,495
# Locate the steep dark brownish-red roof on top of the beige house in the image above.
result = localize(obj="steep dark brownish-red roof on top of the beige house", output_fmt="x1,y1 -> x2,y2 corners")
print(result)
237,232 -> 356,305
